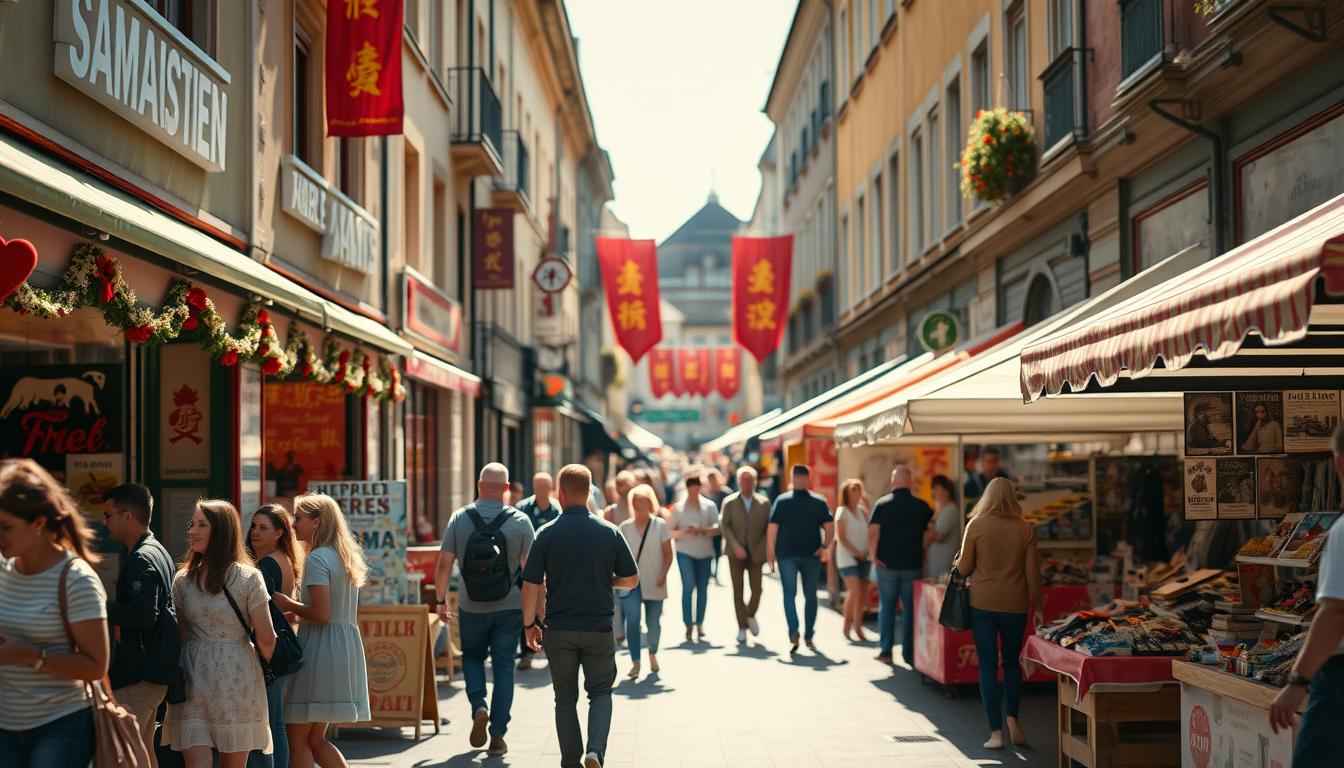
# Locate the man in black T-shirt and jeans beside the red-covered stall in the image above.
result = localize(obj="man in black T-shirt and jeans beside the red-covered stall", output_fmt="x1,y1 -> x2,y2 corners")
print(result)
868,464 -> 933,667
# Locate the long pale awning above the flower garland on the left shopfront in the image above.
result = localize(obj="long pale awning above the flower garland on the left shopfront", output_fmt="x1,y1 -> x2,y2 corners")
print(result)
0,136 -> 413,355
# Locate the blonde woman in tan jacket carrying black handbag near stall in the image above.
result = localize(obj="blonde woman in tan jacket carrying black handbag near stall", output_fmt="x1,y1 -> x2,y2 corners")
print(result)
954,477 -> 1040,749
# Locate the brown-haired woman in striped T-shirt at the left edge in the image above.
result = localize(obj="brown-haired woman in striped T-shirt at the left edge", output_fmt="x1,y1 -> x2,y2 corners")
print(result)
0,459 -> 110,768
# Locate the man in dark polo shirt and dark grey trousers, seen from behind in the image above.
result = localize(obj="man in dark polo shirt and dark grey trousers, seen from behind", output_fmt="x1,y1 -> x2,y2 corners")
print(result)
523,464 -> 640,768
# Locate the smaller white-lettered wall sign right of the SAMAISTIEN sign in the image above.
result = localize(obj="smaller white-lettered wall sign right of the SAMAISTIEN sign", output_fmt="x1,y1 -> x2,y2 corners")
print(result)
280,155 -> 379,274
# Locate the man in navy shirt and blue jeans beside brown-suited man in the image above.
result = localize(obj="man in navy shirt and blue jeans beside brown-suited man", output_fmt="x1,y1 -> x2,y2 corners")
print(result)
766,464 -> 835,654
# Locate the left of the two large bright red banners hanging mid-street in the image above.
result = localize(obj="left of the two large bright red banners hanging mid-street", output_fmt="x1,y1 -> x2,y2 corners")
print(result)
597,237 -> 663,363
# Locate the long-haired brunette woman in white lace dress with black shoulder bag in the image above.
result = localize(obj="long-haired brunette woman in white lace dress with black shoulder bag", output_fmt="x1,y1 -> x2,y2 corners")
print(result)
164,499 -> 276,768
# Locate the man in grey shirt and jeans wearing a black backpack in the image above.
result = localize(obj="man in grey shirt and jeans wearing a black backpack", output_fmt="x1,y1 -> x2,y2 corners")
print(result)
434,463 -> 534,756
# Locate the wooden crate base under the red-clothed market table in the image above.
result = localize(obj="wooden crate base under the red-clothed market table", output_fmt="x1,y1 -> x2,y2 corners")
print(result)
1059,675 -> 1180,768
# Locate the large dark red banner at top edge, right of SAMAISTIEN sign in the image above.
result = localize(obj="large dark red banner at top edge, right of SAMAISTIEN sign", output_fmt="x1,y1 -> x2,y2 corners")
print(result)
327,0 -> 406,136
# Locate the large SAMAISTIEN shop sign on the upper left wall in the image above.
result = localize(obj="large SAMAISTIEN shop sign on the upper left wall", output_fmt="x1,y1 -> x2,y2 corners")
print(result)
52,0 -> 230,172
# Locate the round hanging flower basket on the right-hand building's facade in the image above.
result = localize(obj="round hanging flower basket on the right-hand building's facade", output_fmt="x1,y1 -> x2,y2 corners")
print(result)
958,108 -> 1036,203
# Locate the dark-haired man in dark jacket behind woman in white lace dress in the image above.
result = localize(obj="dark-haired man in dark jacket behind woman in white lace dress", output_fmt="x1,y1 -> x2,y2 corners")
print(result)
102,483 -> 181,765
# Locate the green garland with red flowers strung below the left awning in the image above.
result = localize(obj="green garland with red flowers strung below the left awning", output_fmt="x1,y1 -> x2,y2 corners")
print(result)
4,243 -> 406,402
